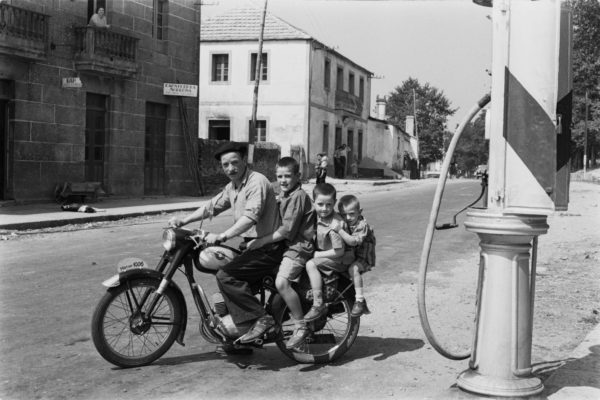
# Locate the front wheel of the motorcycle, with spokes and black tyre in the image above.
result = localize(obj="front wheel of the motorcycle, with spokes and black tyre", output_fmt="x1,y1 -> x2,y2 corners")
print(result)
92,278 -> 183,368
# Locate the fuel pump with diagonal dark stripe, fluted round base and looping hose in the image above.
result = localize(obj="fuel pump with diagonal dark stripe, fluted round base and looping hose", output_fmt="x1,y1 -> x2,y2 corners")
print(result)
418,0 -> 572,397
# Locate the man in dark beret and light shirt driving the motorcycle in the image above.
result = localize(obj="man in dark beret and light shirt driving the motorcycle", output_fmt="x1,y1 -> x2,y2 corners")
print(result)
169,142 -> 285,342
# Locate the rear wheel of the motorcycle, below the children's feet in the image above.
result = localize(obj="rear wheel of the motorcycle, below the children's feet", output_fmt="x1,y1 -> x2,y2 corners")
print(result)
276,290 -> 360,364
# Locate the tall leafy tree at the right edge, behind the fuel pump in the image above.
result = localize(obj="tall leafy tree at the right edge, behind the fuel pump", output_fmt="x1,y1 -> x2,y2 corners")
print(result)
571,0 -> 600,168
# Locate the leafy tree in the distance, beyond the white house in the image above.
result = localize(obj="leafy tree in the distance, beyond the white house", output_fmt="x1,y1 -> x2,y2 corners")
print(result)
386,77 -> 457,165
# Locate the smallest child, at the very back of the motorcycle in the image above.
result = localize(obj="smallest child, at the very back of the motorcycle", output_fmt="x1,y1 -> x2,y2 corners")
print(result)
337,194 -> 375,317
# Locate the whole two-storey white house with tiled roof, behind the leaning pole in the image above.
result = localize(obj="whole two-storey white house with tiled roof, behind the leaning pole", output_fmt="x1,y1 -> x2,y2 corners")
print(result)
198,9 -> 373,177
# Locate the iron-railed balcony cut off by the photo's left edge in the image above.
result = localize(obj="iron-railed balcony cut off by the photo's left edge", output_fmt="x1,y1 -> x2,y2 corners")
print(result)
0,2 -> 50,60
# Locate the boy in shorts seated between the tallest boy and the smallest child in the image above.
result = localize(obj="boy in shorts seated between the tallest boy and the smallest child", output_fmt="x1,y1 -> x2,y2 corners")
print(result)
304,183 -> 348,322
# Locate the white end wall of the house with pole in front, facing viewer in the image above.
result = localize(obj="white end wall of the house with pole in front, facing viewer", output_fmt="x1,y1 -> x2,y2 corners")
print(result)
198,41 -> 310,155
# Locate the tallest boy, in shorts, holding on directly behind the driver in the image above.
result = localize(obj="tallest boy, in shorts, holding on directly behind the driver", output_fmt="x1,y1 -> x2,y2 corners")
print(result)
248,157 -> 317,348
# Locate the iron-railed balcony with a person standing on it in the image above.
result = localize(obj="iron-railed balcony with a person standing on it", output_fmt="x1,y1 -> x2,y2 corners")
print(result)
74,26 -> 139,77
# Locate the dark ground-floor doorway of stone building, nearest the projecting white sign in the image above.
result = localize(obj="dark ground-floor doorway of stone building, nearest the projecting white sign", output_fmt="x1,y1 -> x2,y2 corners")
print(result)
144,103 -> 167,195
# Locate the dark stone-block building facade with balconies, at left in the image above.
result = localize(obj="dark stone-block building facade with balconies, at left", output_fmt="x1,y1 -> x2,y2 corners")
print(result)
0,0 -> 199,201
